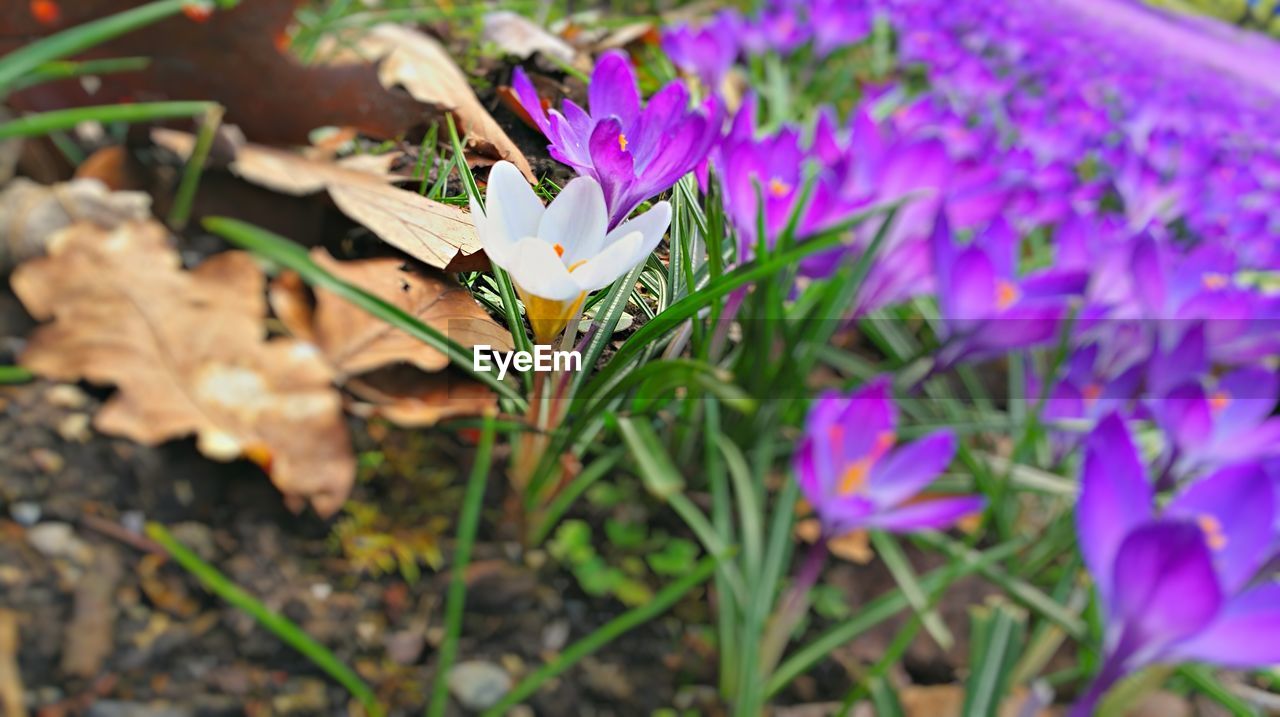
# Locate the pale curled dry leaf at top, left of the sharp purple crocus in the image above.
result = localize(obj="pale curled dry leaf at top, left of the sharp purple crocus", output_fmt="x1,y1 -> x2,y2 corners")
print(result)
356,24 -> 538,182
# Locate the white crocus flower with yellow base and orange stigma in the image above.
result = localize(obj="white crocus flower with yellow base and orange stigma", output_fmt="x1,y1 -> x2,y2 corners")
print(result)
471,161 -> 671,343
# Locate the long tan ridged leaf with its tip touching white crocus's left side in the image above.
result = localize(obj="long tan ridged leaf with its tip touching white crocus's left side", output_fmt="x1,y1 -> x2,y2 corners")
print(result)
151,129 -> 489,271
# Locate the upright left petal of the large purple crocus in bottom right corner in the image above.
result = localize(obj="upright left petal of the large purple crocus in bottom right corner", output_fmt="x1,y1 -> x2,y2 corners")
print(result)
1075,414 -> 1155,602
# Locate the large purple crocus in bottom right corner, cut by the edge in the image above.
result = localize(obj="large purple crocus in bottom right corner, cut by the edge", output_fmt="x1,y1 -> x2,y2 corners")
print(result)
1071,415 -> 1280,717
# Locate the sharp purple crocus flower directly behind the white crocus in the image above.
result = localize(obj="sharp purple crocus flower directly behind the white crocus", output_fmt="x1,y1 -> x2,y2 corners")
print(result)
512,51 -> 722,229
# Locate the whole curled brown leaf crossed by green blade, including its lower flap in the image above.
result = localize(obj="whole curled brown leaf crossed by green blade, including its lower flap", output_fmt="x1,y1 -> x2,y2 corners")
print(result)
269,248 -> 512,426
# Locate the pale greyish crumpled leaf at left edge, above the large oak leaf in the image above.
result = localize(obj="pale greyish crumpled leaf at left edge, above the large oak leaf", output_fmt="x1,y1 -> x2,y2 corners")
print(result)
0,177 -> 151,271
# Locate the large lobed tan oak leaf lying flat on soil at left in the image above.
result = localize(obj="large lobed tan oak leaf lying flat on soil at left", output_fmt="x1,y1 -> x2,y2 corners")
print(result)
12,222 -> 356,516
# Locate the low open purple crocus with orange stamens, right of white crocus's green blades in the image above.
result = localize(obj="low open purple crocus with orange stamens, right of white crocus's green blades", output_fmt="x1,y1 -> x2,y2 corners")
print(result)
794,379 -> 983,539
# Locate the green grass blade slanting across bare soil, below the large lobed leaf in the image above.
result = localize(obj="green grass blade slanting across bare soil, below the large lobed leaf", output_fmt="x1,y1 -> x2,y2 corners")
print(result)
147,522 -> 385,717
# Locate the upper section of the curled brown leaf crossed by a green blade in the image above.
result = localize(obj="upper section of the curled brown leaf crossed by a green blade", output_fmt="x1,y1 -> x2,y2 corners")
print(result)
270,248 -> 511,376
